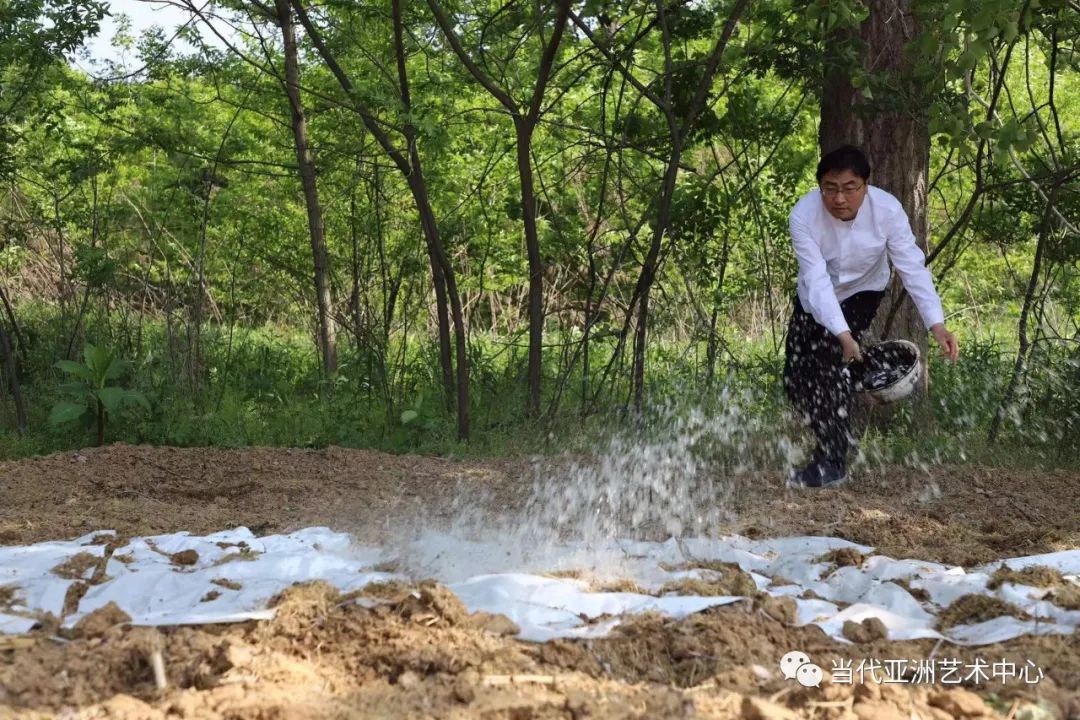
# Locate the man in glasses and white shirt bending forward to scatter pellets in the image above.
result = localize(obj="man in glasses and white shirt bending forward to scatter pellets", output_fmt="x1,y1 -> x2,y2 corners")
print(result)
784,146 -> 959,488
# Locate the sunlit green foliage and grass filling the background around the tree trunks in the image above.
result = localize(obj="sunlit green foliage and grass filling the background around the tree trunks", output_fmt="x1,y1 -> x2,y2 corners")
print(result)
0,0 -> 1080,472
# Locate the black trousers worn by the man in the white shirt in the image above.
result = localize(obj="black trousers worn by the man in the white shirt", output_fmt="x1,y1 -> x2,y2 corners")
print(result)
784,290 -> 885,465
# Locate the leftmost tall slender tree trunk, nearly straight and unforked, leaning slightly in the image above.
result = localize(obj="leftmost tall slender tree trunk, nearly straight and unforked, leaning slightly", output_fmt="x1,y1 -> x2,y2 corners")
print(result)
276,0 -> 337,375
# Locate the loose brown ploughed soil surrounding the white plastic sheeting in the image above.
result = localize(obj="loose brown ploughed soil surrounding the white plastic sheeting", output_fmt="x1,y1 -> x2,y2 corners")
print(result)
0,445 -> 1080,720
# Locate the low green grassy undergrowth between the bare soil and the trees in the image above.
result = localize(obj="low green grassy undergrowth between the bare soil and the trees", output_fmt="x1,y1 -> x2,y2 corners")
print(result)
0,310 -> 1080,467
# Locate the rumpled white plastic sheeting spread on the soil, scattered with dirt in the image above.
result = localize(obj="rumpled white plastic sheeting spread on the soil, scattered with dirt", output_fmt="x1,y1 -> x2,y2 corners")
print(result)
0,528 -> 1080,644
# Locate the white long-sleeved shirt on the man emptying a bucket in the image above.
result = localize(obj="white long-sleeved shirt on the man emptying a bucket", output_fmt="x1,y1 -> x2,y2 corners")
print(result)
788,186 -> 945,335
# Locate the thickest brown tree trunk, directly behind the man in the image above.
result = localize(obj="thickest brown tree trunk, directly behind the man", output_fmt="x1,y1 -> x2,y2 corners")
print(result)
820,0 -> 930,395
